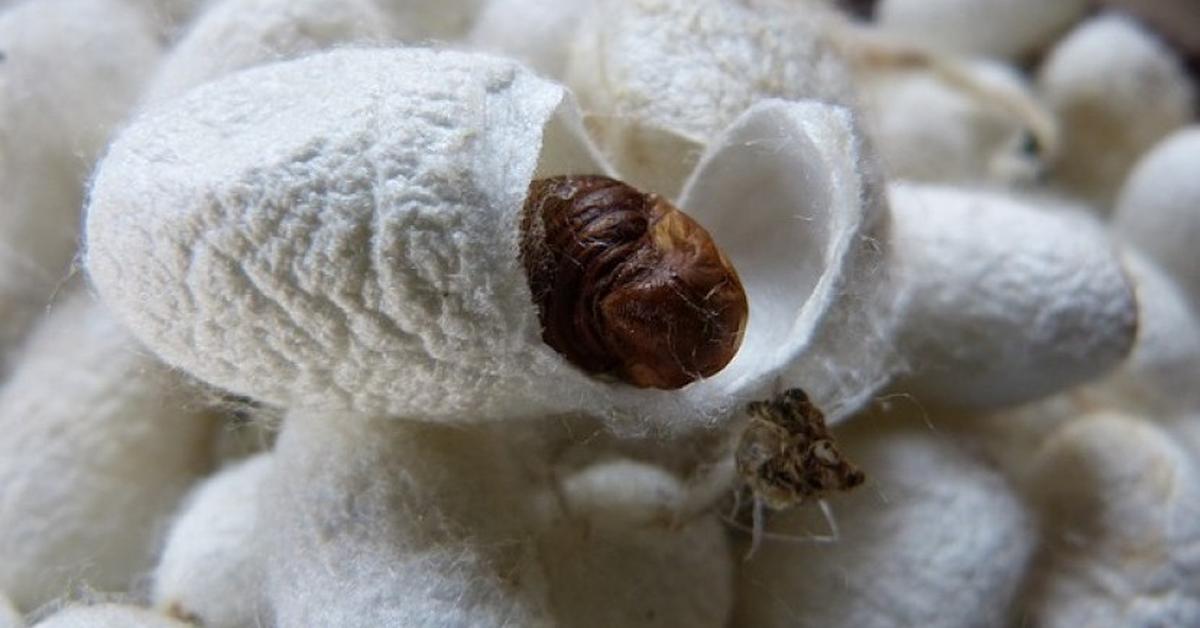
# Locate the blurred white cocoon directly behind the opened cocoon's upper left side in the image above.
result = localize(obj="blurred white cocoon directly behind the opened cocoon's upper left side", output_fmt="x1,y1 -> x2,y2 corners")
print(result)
145,0 -> 389,102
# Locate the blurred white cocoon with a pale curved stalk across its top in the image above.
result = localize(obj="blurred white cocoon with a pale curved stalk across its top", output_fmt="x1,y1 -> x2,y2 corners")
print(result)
858,62 -> 1040,184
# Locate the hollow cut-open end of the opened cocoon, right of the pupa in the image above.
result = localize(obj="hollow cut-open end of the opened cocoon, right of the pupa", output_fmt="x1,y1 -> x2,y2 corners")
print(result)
680,100 -> 898,420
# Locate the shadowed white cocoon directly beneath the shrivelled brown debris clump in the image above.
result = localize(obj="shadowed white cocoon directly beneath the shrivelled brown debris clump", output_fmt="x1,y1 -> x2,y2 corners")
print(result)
733,415 -> 1037,628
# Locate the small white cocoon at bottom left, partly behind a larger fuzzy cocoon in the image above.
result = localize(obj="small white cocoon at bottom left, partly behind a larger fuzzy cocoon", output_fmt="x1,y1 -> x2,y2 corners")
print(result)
152,454 -> 274,628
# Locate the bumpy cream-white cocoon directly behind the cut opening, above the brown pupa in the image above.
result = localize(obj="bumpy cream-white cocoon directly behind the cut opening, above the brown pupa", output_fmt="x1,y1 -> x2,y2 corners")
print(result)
566,0 -> 852,197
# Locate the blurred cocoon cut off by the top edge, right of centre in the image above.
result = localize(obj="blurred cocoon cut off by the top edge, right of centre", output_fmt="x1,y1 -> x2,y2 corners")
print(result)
876,0 -> 1088,59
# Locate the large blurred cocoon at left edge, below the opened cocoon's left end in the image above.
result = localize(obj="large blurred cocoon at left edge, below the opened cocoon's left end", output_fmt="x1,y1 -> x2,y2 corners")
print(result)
0,294 -> 212,610
